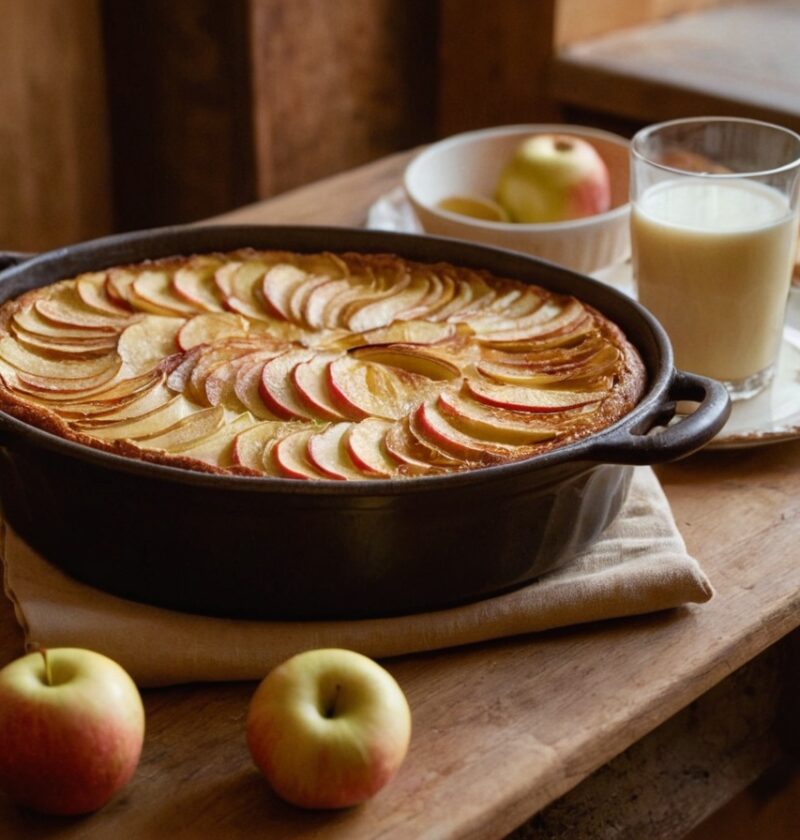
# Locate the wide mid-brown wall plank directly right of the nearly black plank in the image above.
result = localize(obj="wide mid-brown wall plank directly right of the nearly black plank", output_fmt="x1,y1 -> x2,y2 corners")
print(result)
250,0 -> 436,198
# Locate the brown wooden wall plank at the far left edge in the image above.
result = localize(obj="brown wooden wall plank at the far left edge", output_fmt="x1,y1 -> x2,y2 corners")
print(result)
0,0 -> 111,251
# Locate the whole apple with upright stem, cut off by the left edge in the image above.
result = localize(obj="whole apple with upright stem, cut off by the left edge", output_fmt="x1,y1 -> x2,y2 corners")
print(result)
0,648 -> 144,814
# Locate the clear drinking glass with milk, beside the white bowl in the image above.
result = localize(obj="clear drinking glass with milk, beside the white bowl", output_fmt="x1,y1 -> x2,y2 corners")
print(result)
631,117 -> 800,400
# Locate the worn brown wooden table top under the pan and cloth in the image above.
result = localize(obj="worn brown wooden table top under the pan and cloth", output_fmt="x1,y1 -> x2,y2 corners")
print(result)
0,148 -> 800,840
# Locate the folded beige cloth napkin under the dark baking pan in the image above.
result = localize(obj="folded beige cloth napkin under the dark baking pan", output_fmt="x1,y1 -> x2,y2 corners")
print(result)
2,467 -> 712,686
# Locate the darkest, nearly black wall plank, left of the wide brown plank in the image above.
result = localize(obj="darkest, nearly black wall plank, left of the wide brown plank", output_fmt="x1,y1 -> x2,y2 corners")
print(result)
103,0 -> 257,230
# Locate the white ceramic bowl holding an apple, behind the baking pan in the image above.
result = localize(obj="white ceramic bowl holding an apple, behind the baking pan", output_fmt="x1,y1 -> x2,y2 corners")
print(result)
404,125 -> 630,274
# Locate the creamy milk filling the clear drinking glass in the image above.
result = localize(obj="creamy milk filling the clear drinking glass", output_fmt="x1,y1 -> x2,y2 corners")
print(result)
631,178 -> 797,381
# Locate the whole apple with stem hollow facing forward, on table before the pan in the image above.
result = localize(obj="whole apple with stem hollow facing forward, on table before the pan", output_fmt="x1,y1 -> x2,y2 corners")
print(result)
246,648 -> 411,809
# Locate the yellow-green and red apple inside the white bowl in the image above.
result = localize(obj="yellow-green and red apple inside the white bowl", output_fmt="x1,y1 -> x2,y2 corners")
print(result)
495,134 -> 611,223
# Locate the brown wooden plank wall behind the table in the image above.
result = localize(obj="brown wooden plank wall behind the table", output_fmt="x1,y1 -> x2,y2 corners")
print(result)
0,0 -> 752,250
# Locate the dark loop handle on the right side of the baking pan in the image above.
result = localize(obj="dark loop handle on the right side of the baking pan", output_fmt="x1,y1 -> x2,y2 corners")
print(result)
587,370 -> 731,464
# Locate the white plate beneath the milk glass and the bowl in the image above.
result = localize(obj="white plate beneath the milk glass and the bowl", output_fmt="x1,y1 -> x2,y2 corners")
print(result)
367,187 -> 800,449
